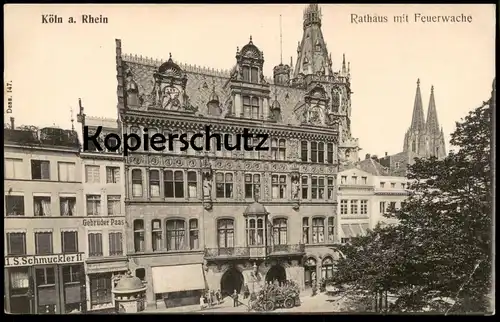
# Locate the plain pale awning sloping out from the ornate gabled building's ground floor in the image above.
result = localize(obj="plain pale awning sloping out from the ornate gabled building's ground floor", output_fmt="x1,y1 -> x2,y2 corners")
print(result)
152,264 -> 205,294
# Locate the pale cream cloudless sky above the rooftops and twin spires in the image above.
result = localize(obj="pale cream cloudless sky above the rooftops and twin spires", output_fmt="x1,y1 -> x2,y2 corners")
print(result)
4,4 -> 495,157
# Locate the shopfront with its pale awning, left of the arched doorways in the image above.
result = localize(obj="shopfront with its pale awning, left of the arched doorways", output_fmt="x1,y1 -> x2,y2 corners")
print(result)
151,264 -> 205,308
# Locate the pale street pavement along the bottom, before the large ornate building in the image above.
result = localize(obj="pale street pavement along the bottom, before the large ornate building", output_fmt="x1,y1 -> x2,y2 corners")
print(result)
145,294 -> 342,314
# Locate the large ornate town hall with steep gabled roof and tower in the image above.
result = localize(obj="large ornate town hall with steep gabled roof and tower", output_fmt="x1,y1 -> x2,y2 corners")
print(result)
115,4 -> 358,307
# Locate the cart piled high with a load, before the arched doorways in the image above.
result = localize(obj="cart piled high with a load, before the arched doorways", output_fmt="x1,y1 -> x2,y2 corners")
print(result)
248,282 -> 300,311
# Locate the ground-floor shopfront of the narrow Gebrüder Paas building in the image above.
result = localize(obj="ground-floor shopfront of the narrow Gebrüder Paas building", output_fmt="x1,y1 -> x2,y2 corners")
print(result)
86,257 -> 128,313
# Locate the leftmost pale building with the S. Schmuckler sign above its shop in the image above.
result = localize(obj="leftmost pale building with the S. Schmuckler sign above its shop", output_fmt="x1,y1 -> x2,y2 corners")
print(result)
4,118 -> 86,314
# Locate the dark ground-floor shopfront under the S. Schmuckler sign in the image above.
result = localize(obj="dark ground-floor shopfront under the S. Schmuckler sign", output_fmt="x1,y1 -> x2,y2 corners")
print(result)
4,253 -> 86,314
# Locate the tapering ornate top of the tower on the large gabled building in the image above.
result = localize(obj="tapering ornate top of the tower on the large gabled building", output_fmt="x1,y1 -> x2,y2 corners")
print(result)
293,4 -> 333,78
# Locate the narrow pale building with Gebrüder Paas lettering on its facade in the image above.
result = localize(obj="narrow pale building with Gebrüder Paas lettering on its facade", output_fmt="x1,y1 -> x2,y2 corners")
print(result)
77,108 -> 128,311
